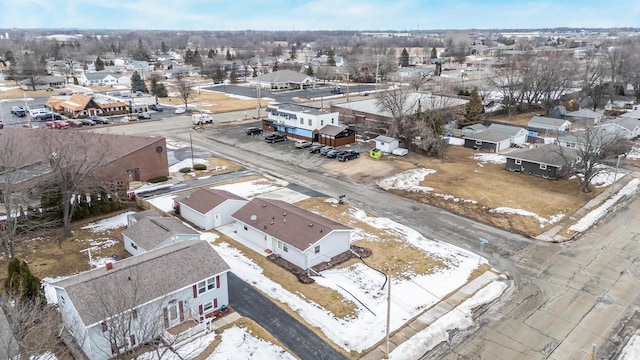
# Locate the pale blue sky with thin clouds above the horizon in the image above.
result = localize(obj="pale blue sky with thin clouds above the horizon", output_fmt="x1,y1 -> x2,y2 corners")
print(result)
0,0 -> 640,31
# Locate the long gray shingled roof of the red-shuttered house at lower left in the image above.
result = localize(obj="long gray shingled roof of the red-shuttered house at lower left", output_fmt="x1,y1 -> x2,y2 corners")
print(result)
53,240 -> 230,326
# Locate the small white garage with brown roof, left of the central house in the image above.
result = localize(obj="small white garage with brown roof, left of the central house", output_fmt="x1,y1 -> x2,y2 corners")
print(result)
178,188 -> 247,230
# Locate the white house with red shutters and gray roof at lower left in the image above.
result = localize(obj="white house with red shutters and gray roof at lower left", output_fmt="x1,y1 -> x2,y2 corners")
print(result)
51,240 -> 229,360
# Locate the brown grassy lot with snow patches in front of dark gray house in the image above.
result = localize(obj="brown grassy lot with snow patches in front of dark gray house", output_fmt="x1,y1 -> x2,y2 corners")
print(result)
325,146 -> 602,236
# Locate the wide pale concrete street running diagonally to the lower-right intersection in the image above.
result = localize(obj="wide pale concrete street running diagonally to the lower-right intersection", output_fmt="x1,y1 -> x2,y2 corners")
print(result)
92,113 -> 640,360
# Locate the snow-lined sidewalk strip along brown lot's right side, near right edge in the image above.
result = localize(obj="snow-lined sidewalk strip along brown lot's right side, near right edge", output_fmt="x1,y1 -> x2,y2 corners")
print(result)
535,171 -> 640,242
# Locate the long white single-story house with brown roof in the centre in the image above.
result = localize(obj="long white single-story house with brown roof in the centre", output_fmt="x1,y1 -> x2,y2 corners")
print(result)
231,198 -> 353,269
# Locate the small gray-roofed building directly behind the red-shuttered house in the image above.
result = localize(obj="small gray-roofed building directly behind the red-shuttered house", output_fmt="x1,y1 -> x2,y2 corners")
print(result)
122,216 -> 200,256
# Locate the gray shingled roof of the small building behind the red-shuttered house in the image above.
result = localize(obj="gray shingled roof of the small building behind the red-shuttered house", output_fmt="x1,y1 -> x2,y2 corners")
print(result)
122,217 -> 200,251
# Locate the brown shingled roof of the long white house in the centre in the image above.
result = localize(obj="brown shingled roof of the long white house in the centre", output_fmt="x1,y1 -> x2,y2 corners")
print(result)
231,198 -> 352,251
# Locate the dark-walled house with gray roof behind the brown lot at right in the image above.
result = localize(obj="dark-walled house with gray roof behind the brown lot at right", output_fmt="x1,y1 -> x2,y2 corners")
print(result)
505,144 -> 578,179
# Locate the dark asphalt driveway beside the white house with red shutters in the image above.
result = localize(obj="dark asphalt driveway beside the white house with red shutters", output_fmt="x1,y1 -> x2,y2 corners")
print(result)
228,273 -> 346,360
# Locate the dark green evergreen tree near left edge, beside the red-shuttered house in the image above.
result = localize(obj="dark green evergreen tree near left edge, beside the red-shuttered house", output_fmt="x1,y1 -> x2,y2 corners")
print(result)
4,257 -> 45,304
